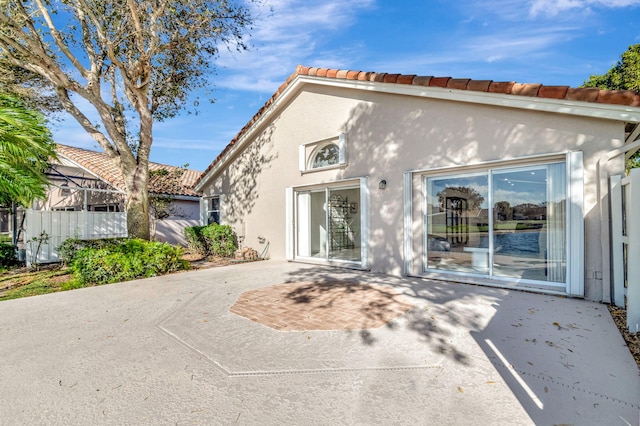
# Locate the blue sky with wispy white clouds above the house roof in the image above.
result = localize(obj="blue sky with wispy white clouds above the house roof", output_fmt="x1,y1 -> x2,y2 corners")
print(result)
53,0 -> 640,170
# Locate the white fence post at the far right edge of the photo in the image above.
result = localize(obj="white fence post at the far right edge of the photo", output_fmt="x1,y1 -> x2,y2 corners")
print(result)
626,169 -> 640,333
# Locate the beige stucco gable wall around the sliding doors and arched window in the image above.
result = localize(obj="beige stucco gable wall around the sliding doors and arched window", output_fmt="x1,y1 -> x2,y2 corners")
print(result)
205,86 -> 624,300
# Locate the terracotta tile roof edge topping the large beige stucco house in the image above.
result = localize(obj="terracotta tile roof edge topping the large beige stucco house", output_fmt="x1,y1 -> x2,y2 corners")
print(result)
196,65 -> 640,184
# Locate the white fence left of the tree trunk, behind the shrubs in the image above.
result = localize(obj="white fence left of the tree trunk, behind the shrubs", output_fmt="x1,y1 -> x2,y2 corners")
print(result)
24,209 -> 127,265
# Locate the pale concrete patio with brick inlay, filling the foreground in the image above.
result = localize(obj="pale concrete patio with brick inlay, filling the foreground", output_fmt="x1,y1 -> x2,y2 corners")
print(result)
0,261 -> 640,425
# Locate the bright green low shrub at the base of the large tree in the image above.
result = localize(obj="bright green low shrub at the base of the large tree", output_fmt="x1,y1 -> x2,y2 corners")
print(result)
71,239 -> 189,284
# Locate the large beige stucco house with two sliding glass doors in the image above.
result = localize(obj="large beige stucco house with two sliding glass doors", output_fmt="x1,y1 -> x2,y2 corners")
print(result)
195,66 -> 640,301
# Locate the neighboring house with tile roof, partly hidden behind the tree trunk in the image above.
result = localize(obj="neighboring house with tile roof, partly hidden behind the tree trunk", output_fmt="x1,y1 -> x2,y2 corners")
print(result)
42,144 -> 201,244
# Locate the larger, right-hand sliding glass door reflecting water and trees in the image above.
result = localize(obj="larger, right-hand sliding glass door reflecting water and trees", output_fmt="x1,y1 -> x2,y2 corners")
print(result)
425,163 -> 567,285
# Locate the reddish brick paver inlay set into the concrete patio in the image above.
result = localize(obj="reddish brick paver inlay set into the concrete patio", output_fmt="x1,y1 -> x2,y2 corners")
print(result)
231,281 -> 413,331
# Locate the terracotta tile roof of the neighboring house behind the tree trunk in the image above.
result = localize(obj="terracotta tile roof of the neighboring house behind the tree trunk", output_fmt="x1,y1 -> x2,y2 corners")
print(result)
56,144 -> 202,196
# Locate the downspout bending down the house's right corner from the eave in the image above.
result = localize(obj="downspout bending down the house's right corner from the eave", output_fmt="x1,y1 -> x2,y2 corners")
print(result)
594,130 -> 640,303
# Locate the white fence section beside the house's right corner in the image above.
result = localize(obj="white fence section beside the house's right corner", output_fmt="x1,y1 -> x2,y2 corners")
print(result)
611,169 -> 640,333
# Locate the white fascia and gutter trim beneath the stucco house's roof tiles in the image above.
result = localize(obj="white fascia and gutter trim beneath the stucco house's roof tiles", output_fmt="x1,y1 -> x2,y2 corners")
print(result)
195,75 -> 640,192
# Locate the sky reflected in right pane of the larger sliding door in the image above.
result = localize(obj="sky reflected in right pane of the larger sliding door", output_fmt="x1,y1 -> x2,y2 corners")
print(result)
493,168 -> 547,206
